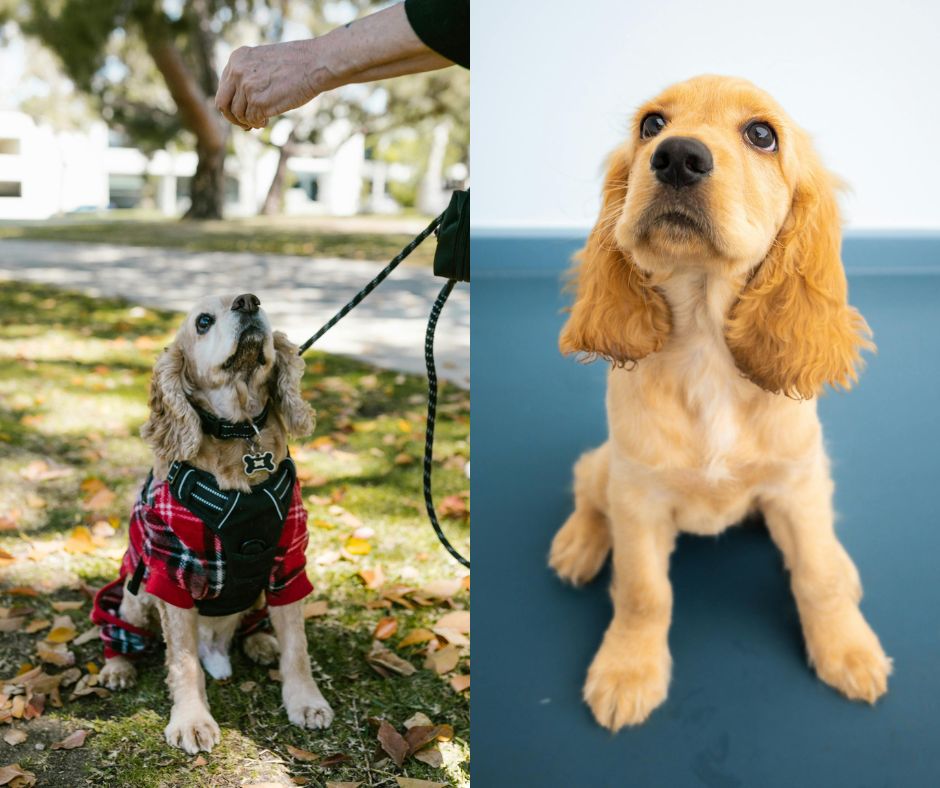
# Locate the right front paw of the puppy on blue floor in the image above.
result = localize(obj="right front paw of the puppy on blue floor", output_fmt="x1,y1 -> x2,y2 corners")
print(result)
809,614 -> 891,703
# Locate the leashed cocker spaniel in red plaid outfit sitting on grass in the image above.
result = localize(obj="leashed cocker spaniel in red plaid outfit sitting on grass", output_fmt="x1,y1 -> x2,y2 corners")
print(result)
92,293 -> 333,753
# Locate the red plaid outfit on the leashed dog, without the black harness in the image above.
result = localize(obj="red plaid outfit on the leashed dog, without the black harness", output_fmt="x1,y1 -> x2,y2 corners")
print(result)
91,470 -> 313,657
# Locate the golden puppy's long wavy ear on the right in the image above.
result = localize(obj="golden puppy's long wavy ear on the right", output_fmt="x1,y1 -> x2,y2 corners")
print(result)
725,151 -> 875,398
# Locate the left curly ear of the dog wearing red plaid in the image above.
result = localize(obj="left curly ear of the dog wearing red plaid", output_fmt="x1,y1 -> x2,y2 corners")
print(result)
140,339 -> 202,463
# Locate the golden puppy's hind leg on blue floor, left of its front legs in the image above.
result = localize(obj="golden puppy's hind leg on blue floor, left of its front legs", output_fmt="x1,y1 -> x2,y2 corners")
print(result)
548,443 -> 610,586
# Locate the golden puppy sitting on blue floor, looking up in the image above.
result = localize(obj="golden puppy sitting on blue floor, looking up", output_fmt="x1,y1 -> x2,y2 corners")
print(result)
550,76 -> 891,730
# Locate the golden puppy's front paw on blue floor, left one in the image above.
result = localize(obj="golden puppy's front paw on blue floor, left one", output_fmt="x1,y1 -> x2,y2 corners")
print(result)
584,649 -> 670,732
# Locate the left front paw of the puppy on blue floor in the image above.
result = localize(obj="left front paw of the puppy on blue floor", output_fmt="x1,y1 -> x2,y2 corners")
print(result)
584,632 -> 672,732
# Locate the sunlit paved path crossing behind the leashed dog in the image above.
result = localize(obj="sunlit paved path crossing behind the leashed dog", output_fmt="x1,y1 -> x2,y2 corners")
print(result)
0,240 -> 470,387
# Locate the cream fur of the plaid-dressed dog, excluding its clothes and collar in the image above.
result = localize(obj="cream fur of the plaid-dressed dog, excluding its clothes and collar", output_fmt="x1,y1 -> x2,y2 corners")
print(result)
101,294 -> 333,754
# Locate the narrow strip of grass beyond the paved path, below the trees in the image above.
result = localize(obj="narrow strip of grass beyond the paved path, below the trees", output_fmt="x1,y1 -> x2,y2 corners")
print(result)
0,211 -> 434,265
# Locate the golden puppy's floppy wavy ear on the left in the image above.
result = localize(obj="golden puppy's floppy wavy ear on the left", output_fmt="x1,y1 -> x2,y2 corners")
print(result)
558,146 -> 670,366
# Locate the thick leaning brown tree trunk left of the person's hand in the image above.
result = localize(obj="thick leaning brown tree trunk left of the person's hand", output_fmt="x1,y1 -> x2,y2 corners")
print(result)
141,10 -> 229,219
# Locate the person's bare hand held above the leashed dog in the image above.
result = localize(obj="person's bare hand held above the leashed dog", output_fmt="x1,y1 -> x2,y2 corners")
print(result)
215,39 -> 323,129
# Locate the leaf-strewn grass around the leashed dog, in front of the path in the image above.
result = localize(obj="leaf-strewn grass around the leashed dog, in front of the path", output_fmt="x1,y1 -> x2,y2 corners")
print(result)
0,280 -> 470,788
